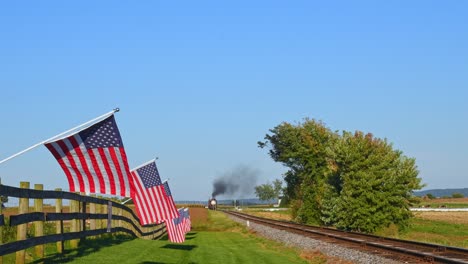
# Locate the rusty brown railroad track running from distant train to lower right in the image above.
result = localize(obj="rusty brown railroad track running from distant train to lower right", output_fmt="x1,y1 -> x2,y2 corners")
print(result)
224,211 -> 468,263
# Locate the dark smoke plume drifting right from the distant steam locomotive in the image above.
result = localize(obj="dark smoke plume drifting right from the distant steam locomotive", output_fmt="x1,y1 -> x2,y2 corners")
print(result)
211,165 -> 259,198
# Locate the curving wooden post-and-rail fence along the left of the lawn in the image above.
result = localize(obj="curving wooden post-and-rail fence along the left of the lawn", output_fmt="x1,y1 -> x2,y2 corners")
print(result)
0,182 -> 166,264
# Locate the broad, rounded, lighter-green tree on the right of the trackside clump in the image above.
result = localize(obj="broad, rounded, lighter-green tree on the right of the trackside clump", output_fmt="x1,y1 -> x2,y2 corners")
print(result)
322,132 -> 421,233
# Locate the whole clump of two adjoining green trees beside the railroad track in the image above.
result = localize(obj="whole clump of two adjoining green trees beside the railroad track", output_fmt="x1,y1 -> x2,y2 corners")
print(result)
258,119 -> 422,233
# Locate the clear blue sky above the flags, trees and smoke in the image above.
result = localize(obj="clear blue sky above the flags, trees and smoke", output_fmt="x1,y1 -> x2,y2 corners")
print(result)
0,0 -> 468,200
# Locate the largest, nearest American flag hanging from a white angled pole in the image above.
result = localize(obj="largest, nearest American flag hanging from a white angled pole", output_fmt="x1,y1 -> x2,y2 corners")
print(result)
45,115 -> 133,197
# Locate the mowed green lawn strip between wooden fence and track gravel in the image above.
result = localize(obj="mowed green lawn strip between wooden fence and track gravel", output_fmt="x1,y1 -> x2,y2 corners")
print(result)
32,208 -> 326,264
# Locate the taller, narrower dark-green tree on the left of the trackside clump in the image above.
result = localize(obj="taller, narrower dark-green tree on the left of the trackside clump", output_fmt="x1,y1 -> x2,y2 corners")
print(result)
258,119 -> 336,224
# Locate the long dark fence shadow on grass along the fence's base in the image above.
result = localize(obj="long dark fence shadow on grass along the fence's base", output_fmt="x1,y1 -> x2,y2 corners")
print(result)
31,235 -> 134,264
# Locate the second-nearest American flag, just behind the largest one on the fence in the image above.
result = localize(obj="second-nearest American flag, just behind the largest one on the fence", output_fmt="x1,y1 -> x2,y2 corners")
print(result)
131,160 -> 179,225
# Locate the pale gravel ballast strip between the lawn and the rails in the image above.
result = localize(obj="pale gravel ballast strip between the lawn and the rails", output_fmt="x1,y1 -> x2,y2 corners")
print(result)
228,215 -> 403,264
